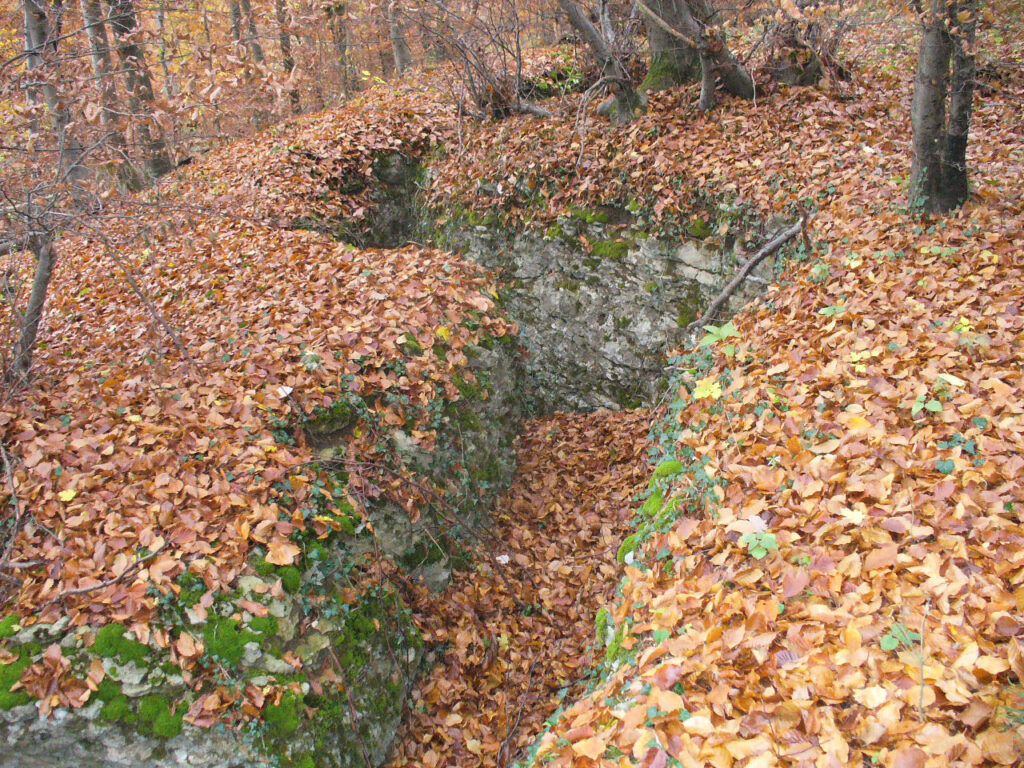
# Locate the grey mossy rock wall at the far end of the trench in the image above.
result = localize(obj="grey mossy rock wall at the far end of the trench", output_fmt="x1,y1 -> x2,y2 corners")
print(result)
453,214 -> 772,410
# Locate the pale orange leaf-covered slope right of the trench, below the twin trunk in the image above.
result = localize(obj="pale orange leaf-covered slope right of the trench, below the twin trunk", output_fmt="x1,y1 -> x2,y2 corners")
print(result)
539,239 -> 1024,766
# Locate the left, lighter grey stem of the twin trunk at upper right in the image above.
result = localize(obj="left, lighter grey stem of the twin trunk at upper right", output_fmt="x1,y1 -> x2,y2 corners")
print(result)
910,0 -> 952,211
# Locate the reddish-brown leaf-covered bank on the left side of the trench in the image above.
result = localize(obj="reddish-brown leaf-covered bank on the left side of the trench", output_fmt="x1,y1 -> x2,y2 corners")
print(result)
0,220 -> 509,645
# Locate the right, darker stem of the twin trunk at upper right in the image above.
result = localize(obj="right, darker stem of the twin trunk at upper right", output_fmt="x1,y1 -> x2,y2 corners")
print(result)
941,0 -> 978,211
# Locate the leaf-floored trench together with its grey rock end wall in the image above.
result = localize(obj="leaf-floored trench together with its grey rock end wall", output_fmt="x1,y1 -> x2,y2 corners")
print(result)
307,156 -> 771,768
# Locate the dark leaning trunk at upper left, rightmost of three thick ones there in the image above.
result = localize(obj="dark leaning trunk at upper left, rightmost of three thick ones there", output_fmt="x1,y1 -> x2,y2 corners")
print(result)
108,0 -> 174,178
